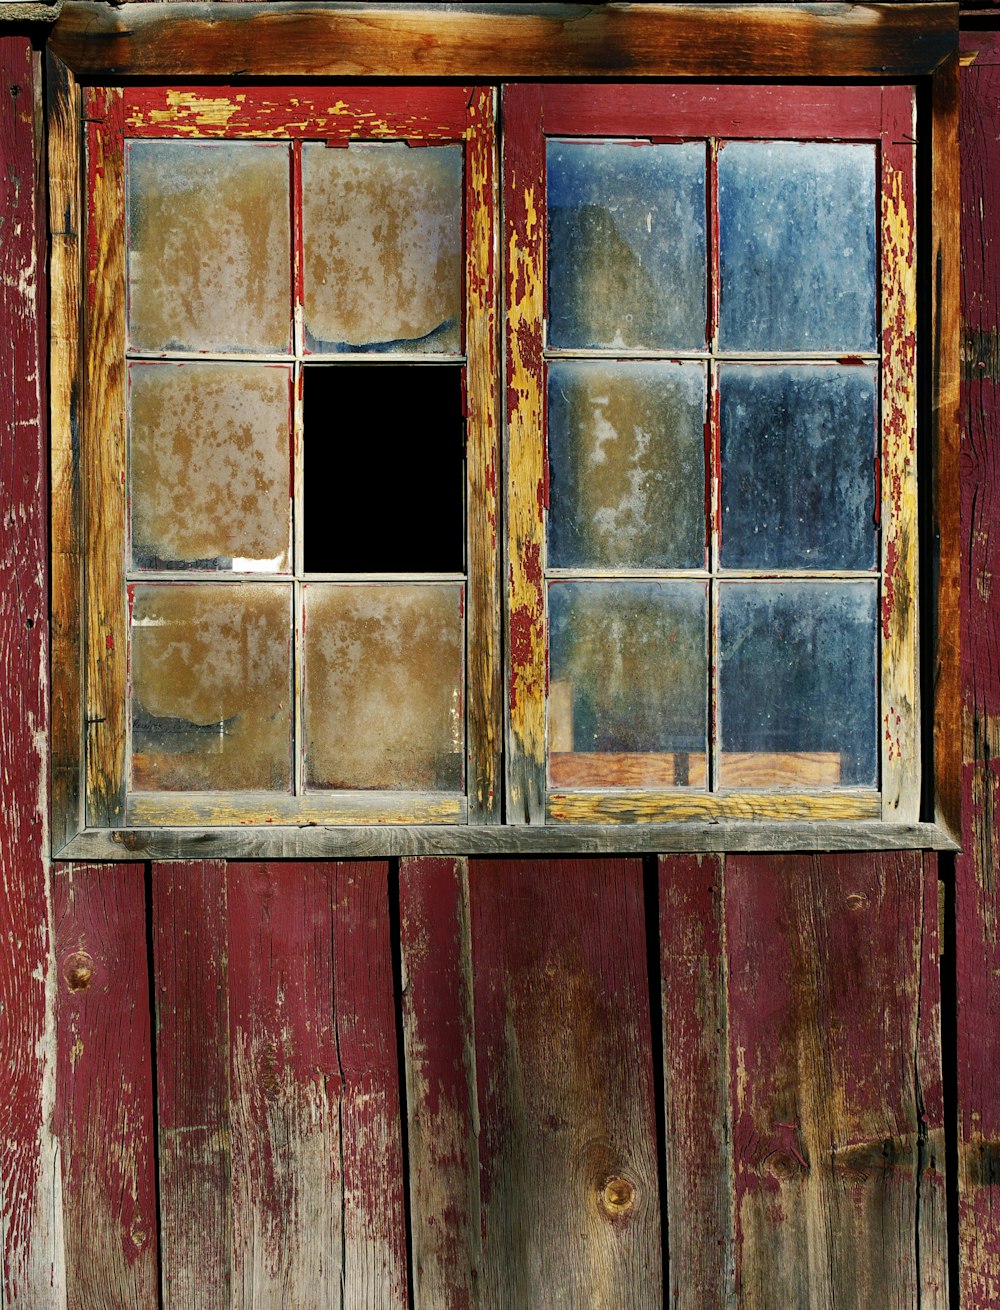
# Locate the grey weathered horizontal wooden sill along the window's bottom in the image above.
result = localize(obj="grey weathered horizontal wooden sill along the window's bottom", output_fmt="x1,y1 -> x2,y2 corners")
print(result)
54,821 -> 958,861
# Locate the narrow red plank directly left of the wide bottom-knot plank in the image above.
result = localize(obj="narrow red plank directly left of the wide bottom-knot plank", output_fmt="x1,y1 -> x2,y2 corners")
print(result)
400,859 -> 482,1310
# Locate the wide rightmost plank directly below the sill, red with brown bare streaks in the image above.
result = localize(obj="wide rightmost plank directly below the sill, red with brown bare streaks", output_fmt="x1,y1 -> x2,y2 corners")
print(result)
726,853 -> 946,1310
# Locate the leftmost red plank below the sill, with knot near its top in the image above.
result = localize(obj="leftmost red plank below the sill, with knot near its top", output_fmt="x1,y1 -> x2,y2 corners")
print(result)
54,865 -> 159,1310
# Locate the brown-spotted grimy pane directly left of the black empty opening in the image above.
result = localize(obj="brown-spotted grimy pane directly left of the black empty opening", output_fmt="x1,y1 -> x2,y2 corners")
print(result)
128,363 -> 291,572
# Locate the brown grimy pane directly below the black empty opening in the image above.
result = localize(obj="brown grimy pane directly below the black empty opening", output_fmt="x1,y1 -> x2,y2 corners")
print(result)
303,583 -> 465,791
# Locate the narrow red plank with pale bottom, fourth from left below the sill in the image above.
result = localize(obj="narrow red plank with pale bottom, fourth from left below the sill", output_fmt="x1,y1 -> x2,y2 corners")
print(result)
334,861 -> 408,1310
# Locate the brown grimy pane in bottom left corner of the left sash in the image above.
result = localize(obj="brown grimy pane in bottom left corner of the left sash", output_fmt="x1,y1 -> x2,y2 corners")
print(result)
131,583 -> 292,791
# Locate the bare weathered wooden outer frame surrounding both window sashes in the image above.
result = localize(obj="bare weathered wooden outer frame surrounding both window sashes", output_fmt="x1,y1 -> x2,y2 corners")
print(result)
47,0 -> 961,859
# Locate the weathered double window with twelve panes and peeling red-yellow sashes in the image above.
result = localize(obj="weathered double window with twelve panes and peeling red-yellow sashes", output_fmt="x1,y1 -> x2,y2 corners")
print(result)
52,7 -> 954,858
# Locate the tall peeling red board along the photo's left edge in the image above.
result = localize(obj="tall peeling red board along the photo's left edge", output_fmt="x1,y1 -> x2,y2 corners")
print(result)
0,33 -> 64,1310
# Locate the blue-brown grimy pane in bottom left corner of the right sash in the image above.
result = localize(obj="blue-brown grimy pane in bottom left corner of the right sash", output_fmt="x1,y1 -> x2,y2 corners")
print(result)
548,582 -> 708,787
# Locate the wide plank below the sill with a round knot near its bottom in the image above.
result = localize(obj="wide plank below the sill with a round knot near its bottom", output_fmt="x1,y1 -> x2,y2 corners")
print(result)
469,859 -> 663,1310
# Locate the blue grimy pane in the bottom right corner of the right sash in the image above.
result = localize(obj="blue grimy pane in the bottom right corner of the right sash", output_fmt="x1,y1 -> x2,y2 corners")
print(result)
720,580 -> 878,787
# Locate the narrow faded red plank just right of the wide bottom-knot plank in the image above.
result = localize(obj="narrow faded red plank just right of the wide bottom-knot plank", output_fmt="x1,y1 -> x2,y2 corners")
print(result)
659,855 -> 735,1310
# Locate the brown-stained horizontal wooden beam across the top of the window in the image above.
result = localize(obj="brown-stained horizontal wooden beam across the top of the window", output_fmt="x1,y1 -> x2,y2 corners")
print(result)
51,0 -> 958,80
